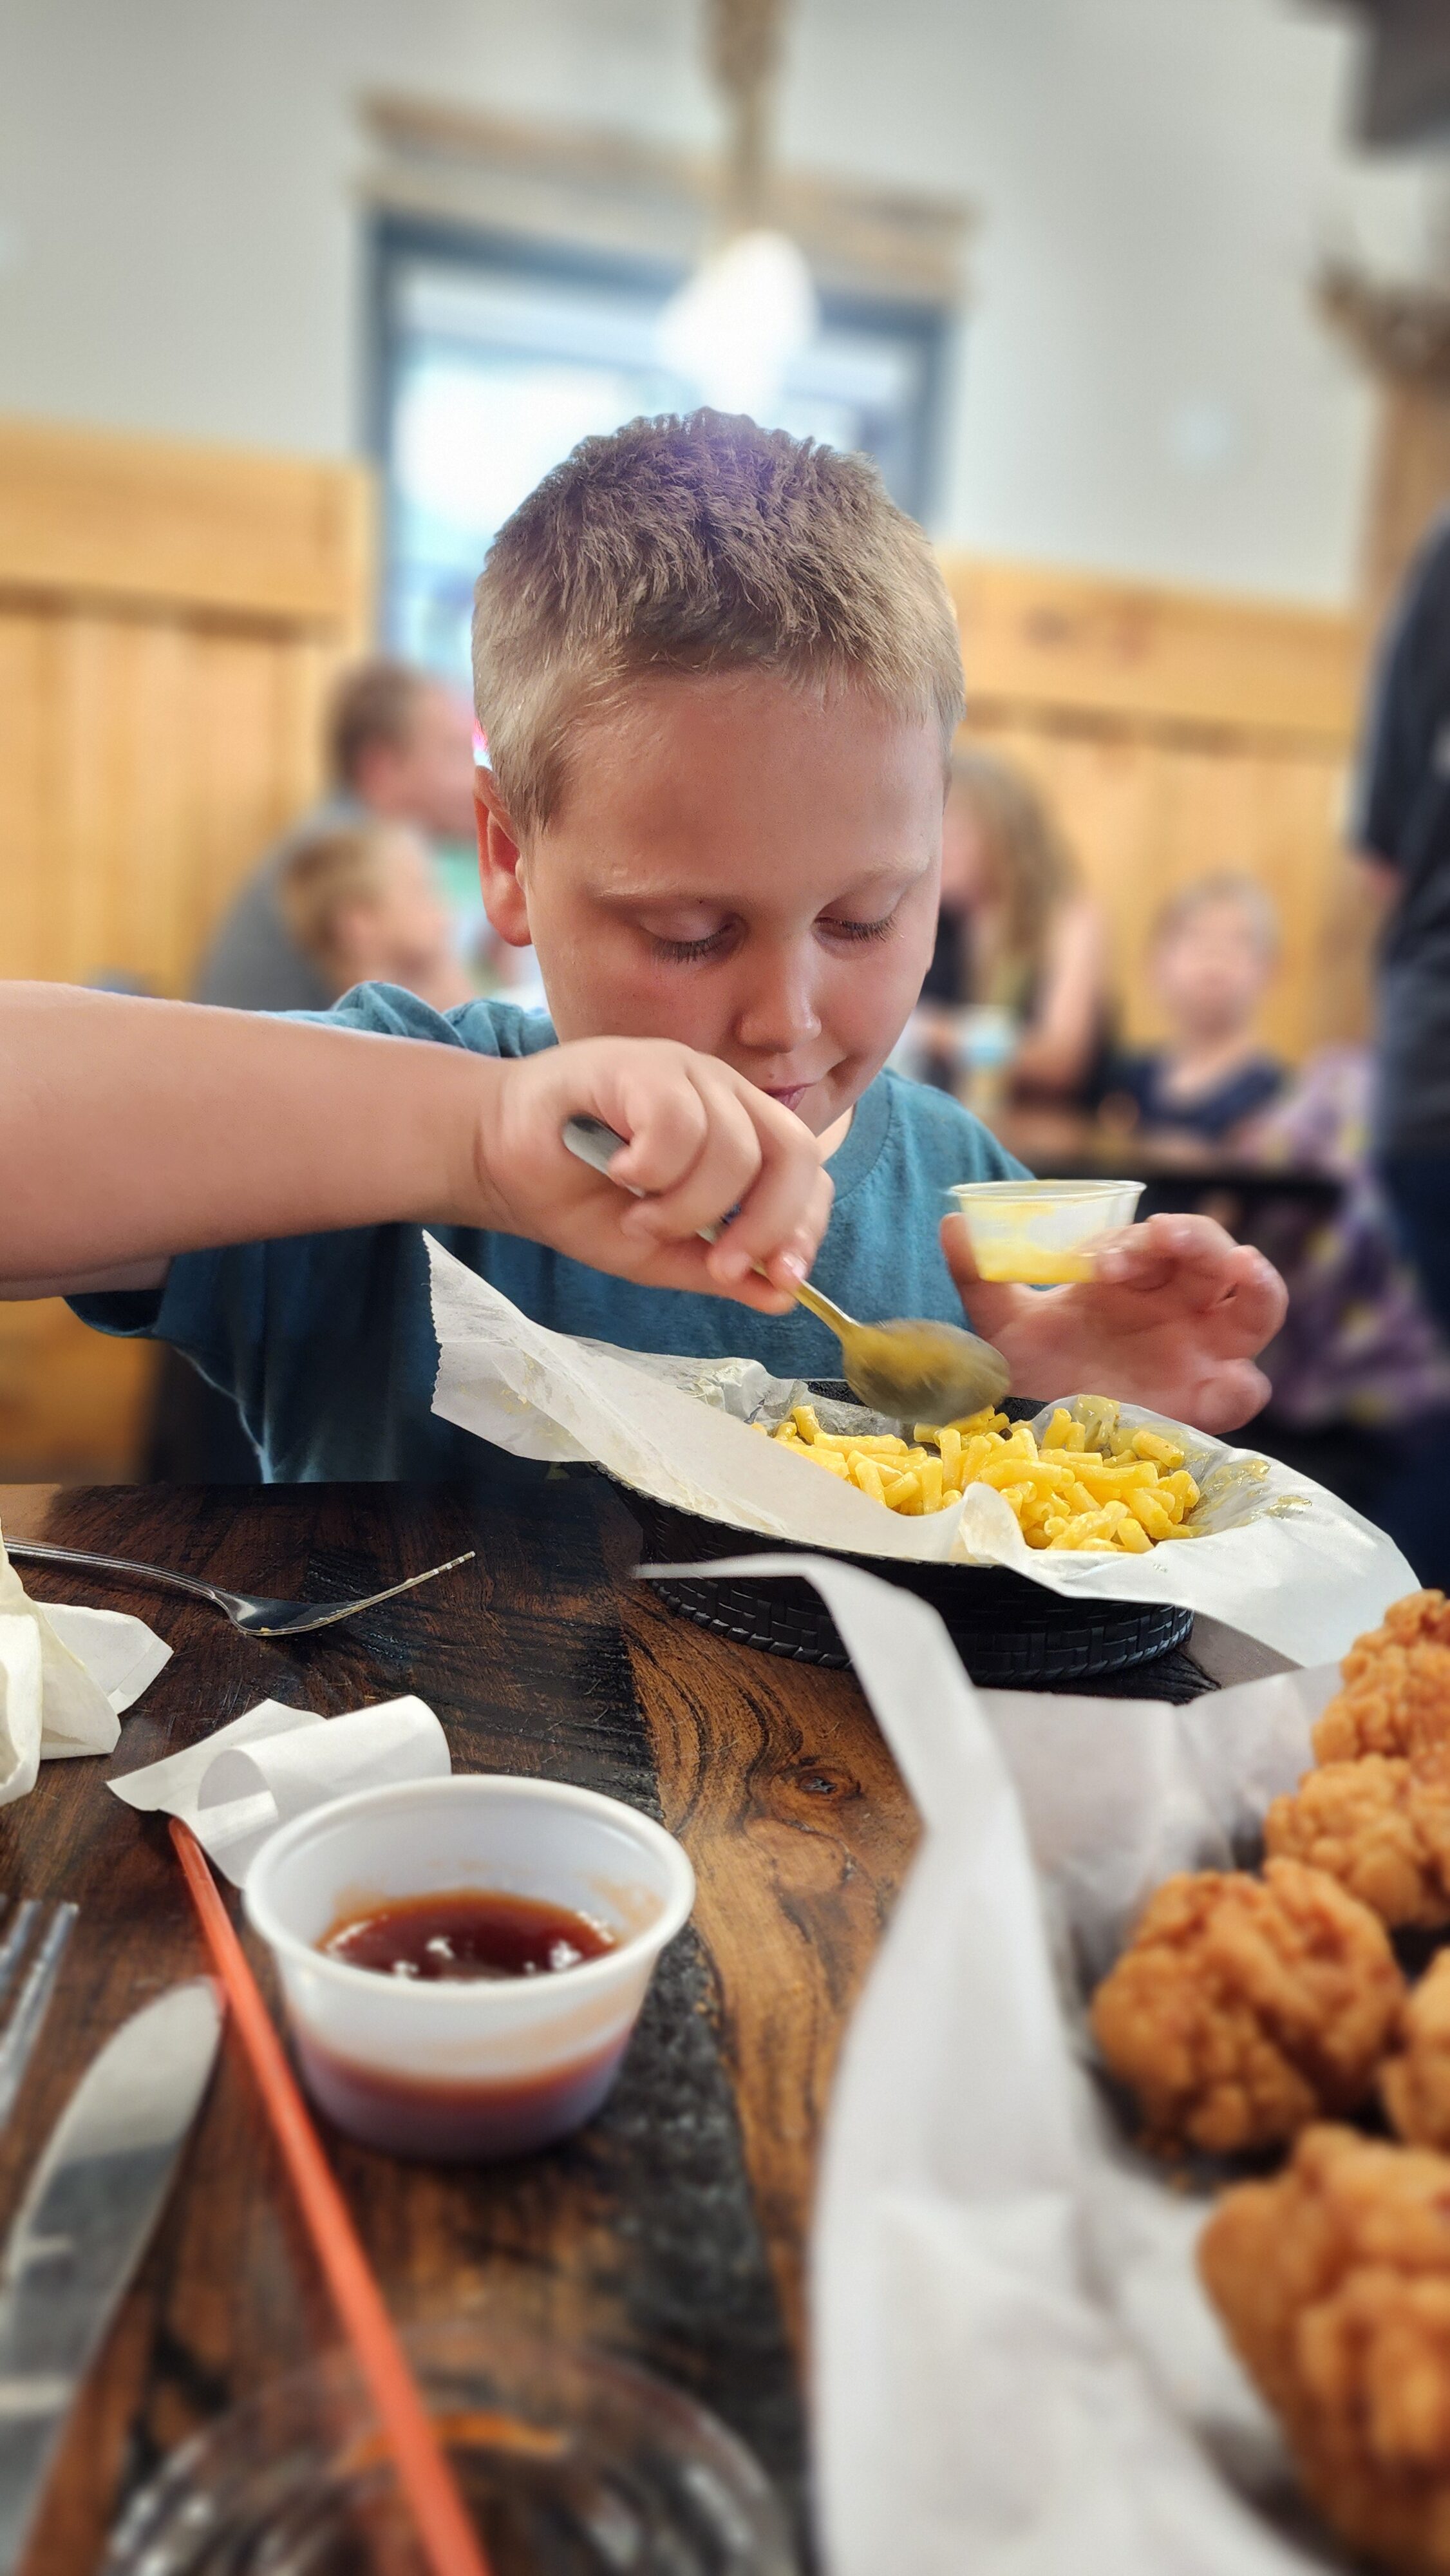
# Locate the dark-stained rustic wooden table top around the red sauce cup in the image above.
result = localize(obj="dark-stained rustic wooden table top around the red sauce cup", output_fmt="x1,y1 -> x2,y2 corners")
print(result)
0,1461 -> 917,2576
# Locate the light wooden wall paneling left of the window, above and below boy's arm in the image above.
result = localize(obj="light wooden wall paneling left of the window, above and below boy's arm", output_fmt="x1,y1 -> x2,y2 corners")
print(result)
0,422 -> 373,1479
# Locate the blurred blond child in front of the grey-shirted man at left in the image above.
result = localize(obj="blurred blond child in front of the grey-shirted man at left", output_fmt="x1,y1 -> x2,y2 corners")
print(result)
278,822 -> 474,1010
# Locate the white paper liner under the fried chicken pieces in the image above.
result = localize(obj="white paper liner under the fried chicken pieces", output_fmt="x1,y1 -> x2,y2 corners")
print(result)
646,1556 -> 1370,2576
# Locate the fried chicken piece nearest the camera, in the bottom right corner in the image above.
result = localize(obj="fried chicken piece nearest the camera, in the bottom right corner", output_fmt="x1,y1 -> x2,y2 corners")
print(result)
1198,2128 -> 1450,2576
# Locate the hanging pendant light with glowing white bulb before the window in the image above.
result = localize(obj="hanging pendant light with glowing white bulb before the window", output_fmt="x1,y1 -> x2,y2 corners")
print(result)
659,0 -> 819,417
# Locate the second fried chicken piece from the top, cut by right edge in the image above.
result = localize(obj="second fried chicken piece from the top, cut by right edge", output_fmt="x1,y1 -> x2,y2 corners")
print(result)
1265,1754 -> 1450,1924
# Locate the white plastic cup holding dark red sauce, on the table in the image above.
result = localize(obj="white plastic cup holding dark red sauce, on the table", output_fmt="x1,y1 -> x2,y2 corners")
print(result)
247,1772 -> 695,2161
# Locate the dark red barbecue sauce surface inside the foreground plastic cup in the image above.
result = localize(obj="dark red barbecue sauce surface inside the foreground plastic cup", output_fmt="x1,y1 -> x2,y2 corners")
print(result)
317,1888 -> 616,1984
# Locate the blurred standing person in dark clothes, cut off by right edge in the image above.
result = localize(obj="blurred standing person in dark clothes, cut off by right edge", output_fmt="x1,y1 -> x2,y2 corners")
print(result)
1357,518 -> 1450,1337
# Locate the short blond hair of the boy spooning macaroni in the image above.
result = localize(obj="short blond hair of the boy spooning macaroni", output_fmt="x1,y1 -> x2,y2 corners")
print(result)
474,412 -> 963,835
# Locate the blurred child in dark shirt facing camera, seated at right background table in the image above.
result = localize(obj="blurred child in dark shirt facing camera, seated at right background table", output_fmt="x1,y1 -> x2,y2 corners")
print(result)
1107,873 -> 1285,1144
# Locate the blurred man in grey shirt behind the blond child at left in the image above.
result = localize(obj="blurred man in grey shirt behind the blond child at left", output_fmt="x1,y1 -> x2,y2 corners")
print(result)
196,662 -> 474,1010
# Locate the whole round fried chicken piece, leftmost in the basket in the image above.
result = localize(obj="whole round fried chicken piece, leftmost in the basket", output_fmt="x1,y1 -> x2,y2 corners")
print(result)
1092,1860 -> 1404,2156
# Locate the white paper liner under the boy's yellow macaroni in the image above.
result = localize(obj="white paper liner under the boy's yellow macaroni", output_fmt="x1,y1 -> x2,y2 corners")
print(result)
428,1239 -> 1414,1664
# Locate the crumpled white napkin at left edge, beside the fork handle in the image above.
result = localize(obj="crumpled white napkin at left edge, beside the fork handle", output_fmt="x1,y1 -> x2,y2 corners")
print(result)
0,1538 -> 170,1806
